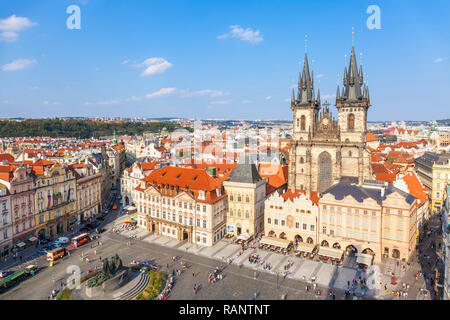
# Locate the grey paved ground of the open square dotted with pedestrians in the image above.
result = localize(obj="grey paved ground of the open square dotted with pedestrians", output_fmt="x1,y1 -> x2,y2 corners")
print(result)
0,208 -> 440,300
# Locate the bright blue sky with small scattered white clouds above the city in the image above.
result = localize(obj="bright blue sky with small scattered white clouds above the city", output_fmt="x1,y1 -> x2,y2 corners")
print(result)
0,0 -> 450,121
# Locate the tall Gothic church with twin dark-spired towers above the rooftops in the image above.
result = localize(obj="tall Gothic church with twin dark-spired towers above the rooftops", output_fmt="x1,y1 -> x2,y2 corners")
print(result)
288,47 -> 372,192
